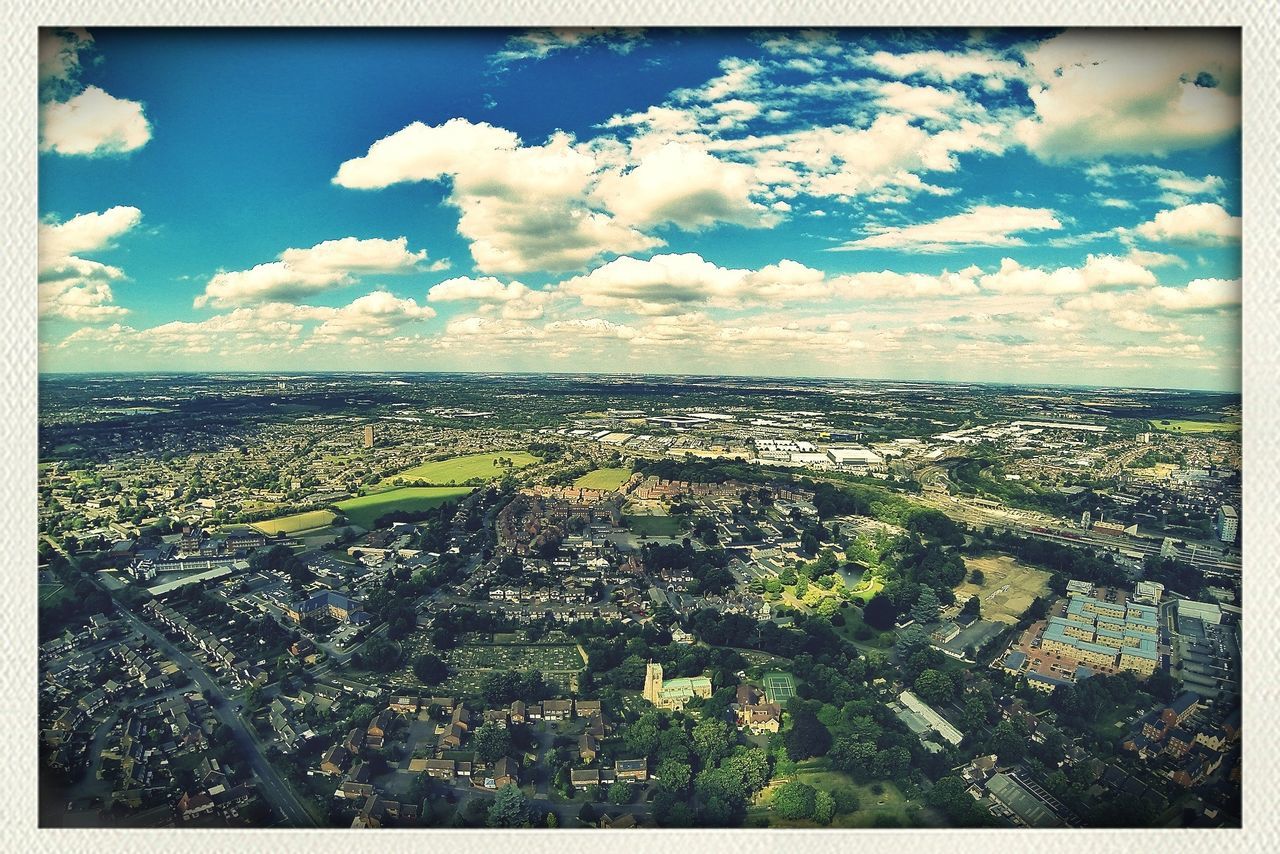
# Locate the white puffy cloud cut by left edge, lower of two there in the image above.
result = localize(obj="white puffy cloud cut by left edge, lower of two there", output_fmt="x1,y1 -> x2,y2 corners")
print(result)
37,205 -> 142,323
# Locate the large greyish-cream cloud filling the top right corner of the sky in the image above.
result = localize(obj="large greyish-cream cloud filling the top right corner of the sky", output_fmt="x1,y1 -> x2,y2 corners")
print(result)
1016,29 -> 1240,160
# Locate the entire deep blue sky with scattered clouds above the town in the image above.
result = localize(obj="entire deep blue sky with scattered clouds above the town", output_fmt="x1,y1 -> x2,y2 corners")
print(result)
37,28 -> 1242,391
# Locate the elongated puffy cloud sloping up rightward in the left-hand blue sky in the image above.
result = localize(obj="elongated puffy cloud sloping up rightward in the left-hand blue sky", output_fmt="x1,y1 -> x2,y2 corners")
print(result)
195,237 -> 426,309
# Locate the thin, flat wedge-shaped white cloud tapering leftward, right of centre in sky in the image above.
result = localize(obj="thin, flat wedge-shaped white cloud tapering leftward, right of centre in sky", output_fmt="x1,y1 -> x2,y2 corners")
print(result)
827,205 -> 1062,252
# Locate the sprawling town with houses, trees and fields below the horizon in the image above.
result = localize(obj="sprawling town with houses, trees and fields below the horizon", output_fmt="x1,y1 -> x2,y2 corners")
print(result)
37,374 -> 1244,828
